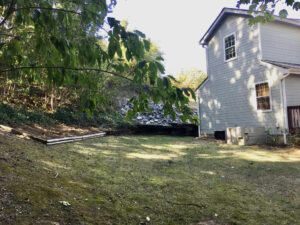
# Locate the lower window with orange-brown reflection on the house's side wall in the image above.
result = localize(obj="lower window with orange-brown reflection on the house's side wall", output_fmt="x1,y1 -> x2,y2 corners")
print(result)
255,82 -> 271,111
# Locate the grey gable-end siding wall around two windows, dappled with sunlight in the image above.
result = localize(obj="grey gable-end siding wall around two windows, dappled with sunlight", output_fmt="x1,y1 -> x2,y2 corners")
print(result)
199,16 -> 283,134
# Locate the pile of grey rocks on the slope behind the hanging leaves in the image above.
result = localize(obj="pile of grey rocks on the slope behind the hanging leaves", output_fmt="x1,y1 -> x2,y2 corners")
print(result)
119,99 -> 197,126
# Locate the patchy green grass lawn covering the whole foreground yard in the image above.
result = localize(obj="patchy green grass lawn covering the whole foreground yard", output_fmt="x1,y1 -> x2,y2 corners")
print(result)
0,134 -> 300,225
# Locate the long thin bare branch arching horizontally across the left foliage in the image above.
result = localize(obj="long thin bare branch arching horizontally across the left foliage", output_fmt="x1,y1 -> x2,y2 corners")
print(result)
0,66 -> 133,82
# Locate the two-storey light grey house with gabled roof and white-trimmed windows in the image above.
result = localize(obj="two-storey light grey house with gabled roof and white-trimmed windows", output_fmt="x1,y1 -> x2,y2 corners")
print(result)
197,8 -> 300,143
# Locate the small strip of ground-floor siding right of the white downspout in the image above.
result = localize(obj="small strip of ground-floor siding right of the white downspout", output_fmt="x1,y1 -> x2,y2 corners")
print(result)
285,75 -> 300,106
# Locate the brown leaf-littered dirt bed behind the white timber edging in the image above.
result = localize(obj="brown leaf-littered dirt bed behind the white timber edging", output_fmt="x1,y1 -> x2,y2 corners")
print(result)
0,124 -> 103,140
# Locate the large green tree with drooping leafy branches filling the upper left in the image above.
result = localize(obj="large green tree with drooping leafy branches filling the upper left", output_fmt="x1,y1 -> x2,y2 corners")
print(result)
0,0 -> 196,122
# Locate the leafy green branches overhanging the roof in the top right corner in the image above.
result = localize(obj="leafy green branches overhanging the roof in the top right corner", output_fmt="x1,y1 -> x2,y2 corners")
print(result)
237,0 -> 300,23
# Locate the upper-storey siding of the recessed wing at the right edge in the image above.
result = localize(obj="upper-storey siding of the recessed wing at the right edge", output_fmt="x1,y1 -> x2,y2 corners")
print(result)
260,22 -> 300,64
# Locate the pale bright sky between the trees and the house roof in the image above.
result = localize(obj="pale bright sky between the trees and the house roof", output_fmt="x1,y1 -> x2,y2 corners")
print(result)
109,0 -> 300,75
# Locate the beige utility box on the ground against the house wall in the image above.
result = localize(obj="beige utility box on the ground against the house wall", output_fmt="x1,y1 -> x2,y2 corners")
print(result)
226,127 -> 266,145
